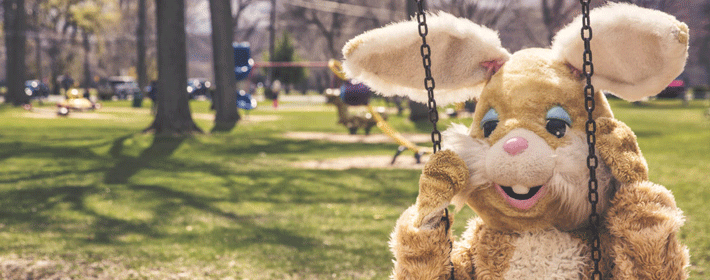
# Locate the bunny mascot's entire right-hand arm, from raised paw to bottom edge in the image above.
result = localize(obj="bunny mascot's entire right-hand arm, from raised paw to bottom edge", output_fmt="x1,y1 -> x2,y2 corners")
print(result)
597,118 -> 688,279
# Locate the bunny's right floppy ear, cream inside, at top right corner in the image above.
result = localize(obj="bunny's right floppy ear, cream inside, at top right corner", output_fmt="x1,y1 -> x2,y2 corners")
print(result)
552,4 -> 688,101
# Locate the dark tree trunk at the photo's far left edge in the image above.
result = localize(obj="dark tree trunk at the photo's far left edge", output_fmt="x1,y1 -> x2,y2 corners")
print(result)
3,0 -> 30,106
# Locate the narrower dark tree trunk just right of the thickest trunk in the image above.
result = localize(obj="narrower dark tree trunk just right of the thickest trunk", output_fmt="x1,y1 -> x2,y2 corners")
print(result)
210,0 -> 239,131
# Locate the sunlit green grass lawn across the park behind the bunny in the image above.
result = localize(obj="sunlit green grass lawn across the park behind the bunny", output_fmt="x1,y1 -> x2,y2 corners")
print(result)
0,97 -> 710,279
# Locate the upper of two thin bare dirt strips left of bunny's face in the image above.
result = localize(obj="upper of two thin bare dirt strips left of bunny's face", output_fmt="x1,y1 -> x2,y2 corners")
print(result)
284,132 -> 431,144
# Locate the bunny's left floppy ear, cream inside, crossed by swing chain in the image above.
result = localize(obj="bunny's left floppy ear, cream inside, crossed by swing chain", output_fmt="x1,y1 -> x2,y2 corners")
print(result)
343,12 -> 510,105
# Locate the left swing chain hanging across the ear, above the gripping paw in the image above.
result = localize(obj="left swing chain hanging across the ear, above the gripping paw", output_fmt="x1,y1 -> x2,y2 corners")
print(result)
414,0 -> 441,153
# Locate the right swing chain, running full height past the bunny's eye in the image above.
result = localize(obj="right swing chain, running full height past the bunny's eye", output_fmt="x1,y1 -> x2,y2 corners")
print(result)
579,0 -> 602,280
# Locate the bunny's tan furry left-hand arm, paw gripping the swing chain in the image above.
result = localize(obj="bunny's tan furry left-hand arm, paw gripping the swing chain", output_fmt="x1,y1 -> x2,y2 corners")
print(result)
390,151 -> 469,279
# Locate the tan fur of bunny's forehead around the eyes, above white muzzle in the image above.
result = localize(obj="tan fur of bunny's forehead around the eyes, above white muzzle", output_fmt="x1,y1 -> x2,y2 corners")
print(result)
471,49 -> 613,144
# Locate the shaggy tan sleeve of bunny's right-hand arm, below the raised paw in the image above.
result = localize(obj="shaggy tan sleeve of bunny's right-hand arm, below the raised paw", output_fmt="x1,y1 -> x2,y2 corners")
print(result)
607,181 -> 688,279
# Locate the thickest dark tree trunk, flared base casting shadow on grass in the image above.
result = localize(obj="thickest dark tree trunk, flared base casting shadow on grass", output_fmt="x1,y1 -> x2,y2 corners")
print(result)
145,0 -> 202,135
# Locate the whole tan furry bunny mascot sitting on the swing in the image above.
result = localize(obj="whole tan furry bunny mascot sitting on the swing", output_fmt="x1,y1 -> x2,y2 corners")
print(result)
344,5 -> 689,279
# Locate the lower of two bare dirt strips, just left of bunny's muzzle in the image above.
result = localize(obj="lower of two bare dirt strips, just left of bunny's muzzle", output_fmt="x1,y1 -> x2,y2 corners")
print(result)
294,152 -> 429,170
